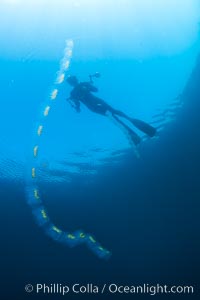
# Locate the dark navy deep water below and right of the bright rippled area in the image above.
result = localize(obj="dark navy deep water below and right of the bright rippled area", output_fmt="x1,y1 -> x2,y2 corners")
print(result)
0,58 -> 200,299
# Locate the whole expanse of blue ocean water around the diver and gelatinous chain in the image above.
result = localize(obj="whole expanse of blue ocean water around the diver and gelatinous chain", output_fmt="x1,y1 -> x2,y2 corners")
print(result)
0,0 -> 200,299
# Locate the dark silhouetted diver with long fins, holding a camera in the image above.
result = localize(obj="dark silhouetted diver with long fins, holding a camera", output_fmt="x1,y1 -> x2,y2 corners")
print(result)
66,72 -> 156,145
